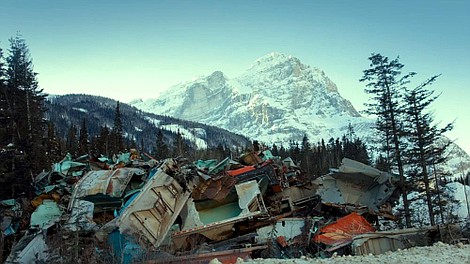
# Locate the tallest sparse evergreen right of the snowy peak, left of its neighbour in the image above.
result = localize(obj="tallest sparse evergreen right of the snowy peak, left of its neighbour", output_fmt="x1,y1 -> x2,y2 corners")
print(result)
360,54 -> 414,227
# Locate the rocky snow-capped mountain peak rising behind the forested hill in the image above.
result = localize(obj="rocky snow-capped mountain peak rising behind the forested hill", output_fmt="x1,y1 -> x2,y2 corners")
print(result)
132,53 -> 372,144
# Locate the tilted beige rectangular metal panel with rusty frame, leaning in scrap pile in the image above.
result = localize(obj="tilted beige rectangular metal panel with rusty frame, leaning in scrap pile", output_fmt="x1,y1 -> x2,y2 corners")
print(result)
117,165 -> 191,248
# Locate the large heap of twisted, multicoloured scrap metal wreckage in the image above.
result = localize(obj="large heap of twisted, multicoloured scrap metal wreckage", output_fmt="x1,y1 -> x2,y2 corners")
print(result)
1,151 -> 456,263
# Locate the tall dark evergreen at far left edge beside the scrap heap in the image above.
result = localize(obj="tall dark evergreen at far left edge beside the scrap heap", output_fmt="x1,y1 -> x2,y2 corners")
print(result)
1,35 -> 49,197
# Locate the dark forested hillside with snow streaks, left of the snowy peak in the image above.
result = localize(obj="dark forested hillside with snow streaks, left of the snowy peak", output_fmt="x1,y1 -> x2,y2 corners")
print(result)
46,94 -> 253,158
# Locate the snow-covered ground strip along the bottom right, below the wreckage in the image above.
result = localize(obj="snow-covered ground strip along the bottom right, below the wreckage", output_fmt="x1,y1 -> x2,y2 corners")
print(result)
233,242 -> 470,264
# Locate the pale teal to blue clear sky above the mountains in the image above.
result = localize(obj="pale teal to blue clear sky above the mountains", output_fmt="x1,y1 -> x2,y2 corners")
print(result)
0,0 -> 470,153
